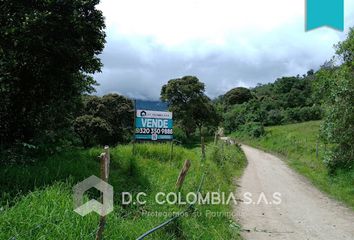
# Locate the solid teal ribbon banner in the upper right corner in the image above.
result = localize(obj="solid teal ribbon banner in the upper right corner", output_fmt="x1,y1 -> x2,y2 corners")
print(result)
306,0 -> 344,31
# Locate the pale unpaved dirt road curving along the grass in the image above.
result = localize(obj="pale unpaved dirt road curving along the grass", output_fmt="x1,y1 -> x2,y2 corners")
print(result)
235,146 -> 354,240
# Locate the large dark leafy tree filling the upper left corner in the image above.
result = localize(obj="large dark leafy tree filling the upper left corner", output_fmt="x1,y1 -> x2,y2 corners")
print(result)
0,0 -> 105,145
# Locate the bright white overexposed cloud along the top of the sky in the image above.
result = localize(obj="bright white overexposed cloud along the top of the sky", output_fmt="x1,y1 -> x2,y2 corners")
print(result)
99,0 -> 304,46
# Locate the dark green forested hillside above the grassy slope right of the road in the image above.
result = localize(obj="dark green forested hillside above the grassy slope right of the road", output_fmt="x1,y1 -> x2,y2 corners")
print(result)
216,70 -> 323,136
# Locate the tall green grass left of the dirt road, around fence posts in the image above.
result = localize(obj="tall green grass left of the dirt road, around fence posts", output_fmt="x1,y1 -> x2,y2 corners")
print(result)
0,144 -> 245,240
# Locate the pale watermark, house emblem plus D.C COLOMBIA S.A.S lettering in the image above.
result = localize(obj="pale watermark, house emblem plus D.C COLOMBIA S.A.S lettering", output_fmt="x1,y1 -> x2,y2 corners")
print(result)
73,175 -> 282,216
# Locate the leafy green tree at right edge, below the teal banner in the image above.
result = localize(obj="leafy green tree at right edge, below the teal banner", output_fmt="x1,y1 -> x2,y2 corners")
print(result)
316,28 -> 354,173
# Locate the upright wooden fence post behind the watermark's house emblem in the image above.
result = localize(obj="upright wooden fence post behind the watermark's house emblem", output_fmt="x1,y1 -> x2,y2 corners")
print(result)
96,146 -> 111,240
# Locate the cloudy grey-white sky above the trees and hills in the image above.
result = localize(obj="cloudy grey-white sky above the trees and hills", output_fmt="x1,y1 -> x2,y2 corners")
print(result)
95,0 -> 354,99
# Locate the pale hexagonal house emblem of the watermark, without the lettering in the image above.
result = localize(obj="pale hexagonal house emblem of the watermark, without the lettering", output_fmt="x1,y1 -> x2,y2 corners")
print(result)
73,175 -> 113,216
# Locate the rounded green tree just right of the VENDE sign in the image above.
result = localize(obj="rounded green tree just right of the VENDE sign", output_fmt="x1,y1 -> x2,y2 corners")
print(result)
161,76 -> 220,137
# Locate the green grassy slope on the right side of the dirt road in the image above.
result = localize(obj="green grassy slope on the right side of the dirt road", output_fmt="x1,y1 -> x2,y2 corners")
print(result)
232,121 -> 354,209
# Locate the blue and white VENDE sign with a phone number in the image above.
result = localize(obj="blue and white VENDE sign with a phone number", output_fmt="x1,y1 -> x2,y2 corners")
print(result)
135,101 -> 173,140
